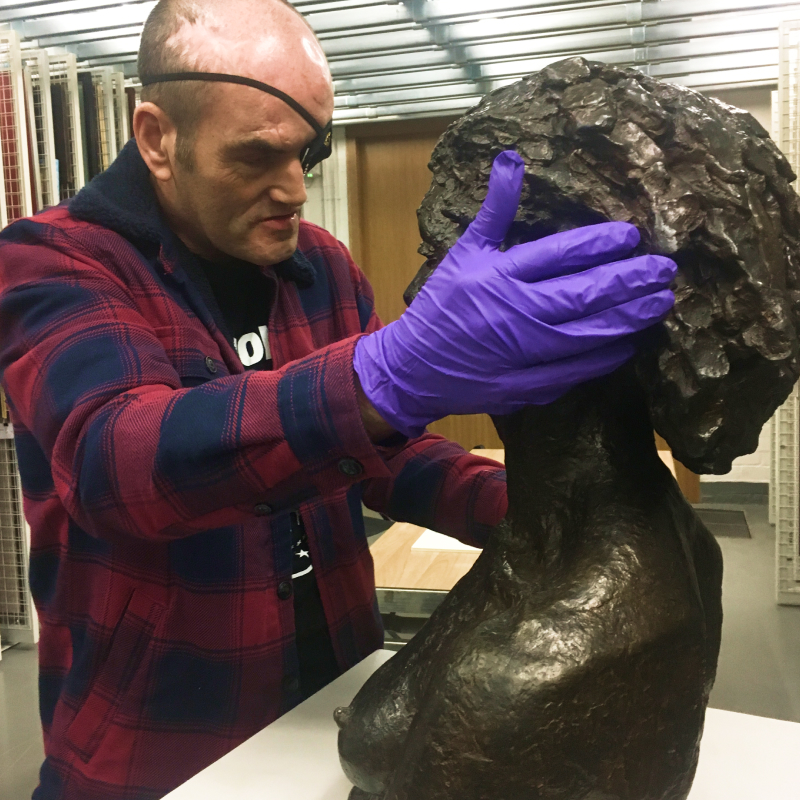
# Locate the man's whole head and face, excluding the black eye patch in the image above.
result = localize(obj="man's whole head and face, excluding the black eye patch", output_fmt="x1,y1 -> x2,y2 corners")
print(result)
133,0 -> 334,267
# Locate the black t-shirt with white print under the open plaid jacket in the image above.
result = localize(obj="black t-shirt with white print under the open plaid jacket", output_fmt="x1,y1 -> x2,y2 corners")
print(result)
198,259 -> 339,697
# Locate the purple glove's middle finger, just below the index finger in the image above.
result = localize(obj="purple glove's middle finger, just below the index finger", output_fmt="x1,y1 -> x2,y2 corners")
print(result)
517,255 -> 678,325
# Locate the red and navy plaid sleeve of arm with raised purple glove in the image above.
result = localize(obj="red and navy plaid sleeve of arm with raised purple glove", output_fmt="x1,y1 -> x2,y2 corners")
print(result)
0,220 -> 391,540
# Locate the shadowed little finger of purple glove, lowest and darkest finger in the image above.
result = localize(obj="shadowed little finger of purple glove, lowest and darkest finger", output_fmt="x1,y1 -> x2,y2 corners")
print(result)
490,340 -> 636,414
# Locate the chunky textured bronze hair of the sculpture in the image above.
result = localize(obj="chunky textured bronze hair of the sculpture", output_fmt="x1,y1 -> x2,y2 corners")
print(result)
407,58 -> 800,473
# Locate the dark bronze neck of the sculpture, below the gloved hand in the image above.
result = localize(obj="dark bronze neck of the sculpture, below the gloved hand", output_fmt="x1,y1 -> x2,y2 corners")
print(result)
495,368 -> 670,561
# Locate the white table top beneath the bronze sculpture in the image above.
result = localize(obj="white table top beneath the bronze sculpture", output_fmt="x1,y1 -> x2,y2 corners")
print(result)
165,650 -> 800,800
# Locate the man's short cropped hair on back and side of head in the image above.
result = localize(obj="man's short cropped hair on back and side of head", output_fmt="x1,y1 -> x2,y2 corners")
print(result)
138,0 -> 305,167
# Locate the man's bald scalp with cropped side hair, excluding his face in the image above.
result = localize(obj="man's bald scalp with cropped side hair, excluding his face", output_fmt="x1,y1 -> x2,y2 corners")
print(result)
139,0 -> 331,164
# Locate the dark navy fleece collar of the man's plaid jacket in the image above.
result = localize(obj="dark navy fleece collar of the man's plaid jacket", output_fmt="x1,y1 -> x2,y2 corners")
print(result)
69,139 -> 316,289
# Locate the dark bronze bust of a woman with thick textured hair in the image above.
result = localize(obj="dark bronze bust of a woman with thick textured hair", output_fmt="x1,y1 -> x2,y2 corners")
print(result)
337,59 -> 800,800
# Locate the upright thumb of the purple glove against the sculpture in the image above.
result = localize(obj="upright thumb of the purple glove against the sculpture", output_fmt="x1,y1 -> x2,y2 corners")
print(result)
461,150 -> 525,246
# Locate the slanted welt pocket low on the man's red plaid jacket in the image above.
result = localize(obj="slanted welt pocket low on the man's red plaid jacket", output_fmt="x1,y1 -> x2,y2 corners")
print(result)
66,590 -> 164,762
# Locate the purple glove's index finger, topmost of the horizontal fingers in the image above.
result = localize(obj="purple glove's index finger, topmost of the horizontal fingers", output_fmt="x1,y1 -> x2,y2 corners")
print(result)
506,222 -> 640,283
